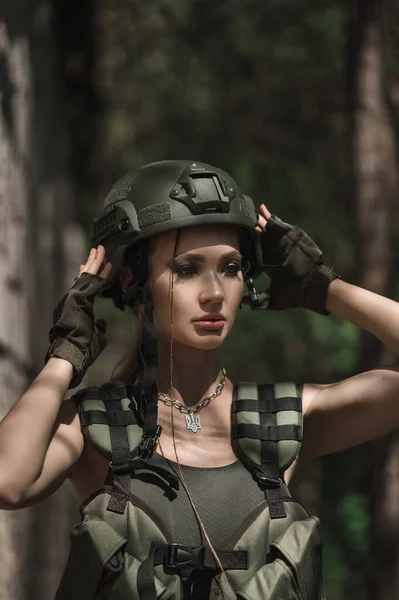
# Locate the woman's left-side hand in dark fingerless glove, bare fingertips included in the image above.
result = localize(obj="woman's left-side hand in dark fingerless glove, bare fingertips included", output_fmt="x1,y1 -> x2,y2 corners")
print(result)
45,246 -> 112,389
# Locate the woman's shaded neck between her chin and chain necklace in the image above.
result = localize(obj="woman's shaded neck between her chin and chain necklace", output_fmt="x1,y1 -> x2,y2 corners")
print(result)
157,342 -> 225,406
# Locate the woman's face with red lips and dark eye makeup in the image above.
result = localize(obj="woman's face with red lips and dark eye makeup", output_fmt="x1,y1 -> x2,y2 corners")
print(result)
149,225 -> 244,350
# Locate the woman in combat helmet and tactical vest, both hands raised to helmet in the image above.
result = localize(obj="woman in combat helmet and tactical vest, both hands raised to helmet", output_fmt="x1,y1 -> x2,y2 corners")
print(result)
0,161 -> 399,600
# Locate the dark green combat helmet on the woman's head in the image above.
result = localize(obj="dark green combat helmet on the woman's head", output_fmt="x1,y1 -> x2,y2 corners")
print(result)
91,160 -> 262,310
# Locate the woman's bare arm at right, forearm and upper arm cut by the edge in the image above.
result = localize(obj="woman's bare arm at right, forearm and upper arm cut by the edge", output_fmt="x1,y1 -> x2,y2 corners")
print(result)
299,279 -> 399,462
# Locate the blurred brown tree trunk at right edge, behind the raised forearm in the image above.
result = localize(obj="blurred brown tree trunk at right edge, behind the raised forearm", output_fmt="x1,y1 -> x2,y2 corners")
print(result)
349,0 -> 399,600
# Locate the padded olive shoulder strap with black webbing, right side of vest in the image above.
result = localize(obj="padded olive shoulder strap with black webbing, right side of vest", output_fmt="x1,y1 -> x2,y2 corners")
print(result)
231,383 -> 302,519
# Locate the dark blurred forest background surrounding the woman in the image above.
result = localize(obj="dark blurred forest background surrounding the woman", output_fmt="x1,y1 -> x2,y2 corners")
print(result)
0,0 -> 399,600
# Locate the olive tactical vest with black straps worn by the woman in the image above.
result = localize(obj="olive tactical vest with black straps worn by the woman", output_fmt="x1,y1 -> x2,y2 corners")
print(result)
55,382 -> 324,600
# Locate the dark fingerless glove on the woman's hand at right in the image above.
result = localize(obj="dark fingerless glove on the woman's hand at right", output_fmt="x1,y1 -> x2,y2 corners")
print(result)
260,213 -> 339,315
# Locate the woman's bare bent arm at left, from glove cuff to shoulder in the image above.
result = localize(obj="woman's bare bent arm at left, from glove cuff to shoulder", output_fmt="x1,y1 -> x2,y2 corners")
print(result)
0,358 -> 83,509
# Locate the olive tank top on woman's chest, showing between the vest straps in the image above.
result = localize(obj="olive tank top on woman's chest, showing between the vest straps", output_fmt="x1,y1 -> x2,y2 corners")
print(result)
131,453 -> 266,550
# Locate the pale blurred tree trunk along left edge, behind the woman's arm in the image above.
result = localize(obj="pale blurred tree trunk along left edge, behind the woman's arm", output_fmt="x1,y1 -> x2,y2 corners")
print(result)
0,0 -> 83,600
